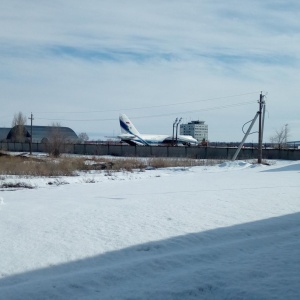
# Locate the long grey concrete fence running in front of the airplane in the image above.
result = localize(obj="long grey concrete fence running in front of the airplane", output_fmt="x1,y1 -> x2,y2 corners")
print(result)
0,142 -> 300,160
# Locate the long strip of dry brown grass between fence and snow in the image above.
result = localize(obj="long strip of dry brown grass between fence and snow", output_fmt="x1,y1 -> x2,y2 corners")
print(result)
0,155 -> 222,177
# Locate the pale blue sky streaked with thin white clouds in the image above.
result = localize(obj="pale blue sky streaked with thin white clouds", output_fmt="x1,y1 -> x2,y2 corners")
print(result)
0,0 -> 300,141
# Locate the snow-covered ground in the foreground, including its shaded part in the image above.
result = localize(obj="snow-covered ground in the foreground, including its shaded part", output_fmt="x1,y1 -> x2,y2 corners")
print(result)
0,161 -> 300,300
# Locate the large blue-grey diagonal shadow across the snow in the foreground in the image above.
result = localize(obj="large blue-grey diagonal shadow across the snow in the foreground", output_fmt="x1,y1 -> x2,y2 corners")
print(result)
0,213 -> 300,300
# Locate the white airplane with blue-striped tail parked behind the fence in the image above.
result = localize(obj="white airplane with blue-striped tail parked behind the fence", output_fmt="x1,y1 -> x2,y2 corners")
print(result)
118,114 -> 198,146
